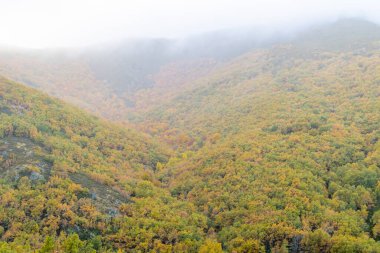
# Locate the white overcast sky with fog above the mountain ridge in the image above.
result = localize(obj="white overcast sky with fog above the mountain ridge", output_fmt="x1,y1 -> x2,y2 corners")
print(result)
0,0 -> 380,48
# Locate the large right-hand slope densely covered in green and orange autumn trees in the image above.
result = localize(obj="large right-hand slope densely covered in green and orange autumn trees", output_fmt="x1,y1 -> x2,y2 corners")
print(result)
127,19 -> 380,252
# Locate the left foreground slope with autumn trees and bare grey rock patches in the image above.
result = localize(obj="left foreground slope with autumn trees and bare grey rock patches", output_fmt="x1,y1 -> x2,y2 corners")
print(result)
0,78 -> 211,252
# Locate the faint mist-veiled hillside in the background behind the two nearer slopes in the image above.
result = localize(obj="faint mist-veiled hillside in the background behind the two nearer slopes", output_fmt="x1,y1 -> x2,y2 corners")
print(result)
0,19 -> 380,120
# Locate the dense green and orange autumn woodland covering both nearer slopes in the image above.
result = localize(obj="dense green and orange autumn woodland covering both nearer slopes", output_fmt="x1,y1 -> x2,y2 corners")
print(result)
0,19 -> 380,253
